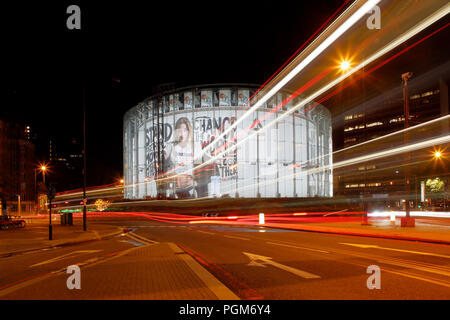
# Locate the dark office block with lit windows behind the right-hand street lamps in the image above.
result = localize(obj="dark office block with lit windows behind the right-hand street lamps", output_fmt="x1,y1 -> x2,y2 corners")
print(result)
334,78 -> 450,209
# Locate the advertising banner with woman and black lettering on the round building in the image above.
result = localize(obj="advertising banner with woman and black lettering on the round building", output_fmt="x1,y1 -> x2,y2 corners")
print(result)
141,110 -> 237,198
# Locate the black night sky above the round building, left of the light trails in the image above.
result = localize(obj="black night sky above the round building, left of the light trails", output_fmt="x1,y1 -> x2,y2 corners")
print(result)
1,0 -> 343,189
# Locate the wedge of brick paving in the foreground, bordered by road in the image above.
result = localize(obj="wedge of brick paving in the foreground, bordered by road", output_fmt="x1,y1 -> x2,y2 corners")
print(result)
0,243 -> 238,300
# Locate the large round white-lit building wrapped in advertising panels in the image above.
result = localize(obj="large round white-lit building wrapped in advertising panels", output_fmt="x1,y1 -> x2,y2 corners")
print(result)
123,84 -> 333,199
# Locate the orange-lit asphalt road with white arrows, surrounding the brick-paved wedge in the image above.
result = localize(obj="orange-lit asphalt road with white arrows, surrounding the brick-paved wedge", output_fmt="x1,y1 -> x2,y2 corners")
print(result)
0,218 -> 450,300
